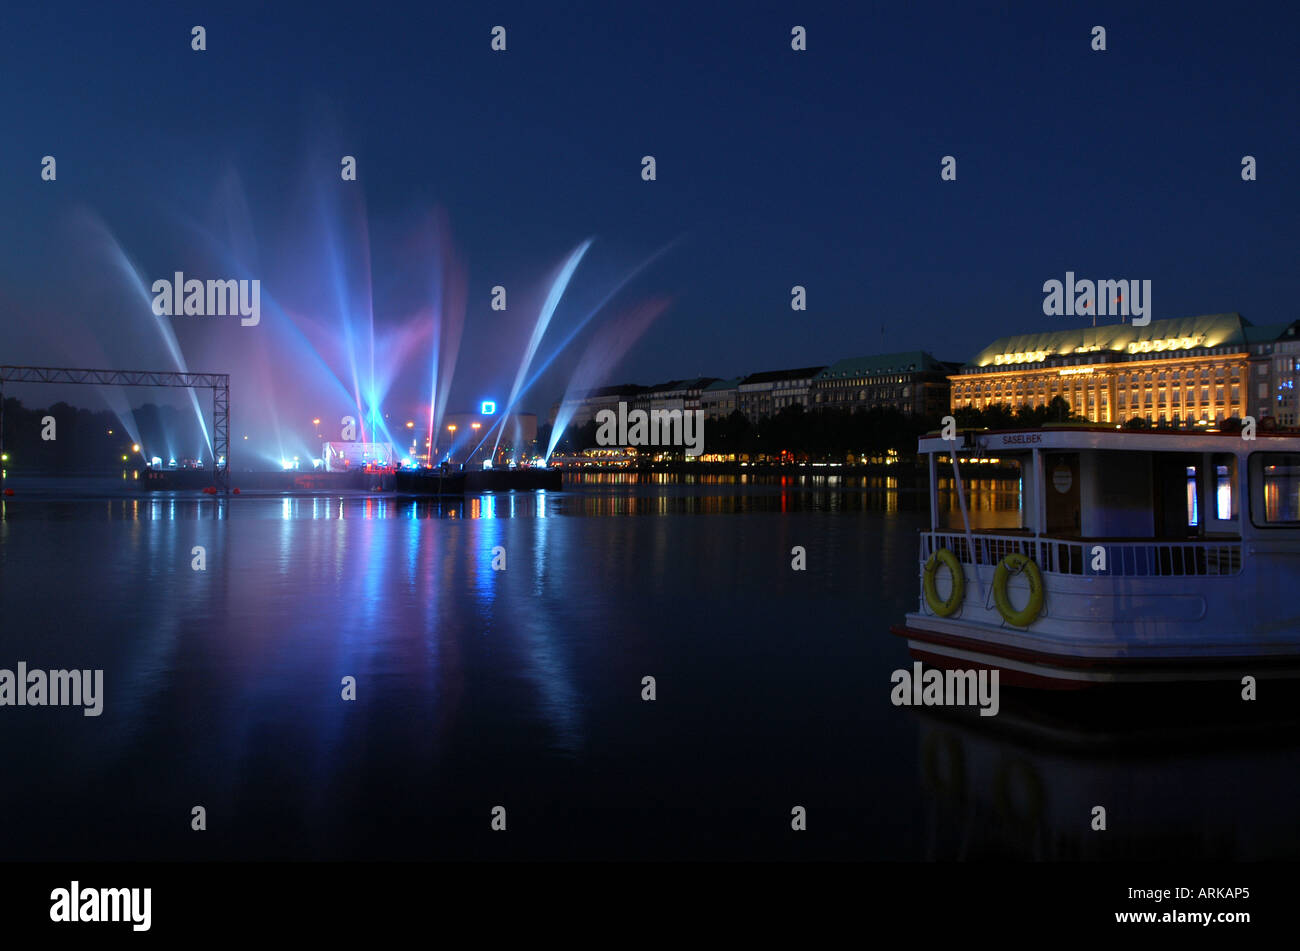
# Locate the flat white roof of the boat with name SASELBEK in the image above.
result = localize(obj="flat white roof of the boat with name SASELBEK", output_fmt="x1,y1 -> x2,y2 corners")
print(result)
917,426 -> 1300,455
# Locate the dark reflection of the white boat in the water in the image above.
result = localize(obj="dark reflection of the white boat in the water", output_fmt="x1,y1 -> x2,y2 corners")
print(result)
914,687 -> 1300,861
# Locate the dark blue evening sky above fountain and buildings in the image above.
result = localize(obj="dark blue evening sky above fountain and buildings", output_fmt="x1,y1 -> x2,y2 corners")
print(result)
0,3 -> 1300,431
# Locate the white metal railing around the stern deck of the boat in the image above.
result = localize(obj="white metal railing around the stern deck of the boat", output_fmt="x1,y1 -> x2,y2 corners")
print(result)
920,531 -> 1242,578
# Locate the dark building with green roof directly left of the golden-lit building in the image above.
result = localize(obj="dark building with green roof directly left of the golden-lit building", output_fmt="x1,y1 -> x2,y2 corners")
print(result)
811,349 -> 959,416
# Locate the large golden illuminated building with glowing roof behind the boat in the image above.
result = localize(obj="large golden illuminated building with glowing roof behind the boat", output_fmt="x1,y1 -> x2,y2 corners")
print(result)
949,313 -> 1269,425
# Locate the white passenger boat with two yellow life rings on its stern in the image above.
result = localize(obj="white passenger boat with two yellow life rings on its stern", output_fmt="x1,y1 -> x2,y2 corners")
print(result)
893,426 -> 1300,687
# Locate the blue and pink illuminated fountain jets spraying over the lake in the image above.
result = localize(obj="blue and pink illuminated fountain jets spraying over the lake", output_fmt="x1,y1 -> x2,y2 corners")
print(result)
45,160 -> 671,491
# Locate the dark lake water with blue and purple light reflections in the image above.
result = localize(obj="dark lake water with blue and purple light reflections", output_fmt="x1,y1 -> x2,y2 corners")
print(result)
0,476 -> 1300,860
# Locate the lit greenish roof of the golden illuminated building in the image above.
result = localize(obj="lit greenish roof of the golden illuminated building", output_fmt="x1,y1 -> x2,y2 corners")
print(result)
966,313 -> 1252,368
